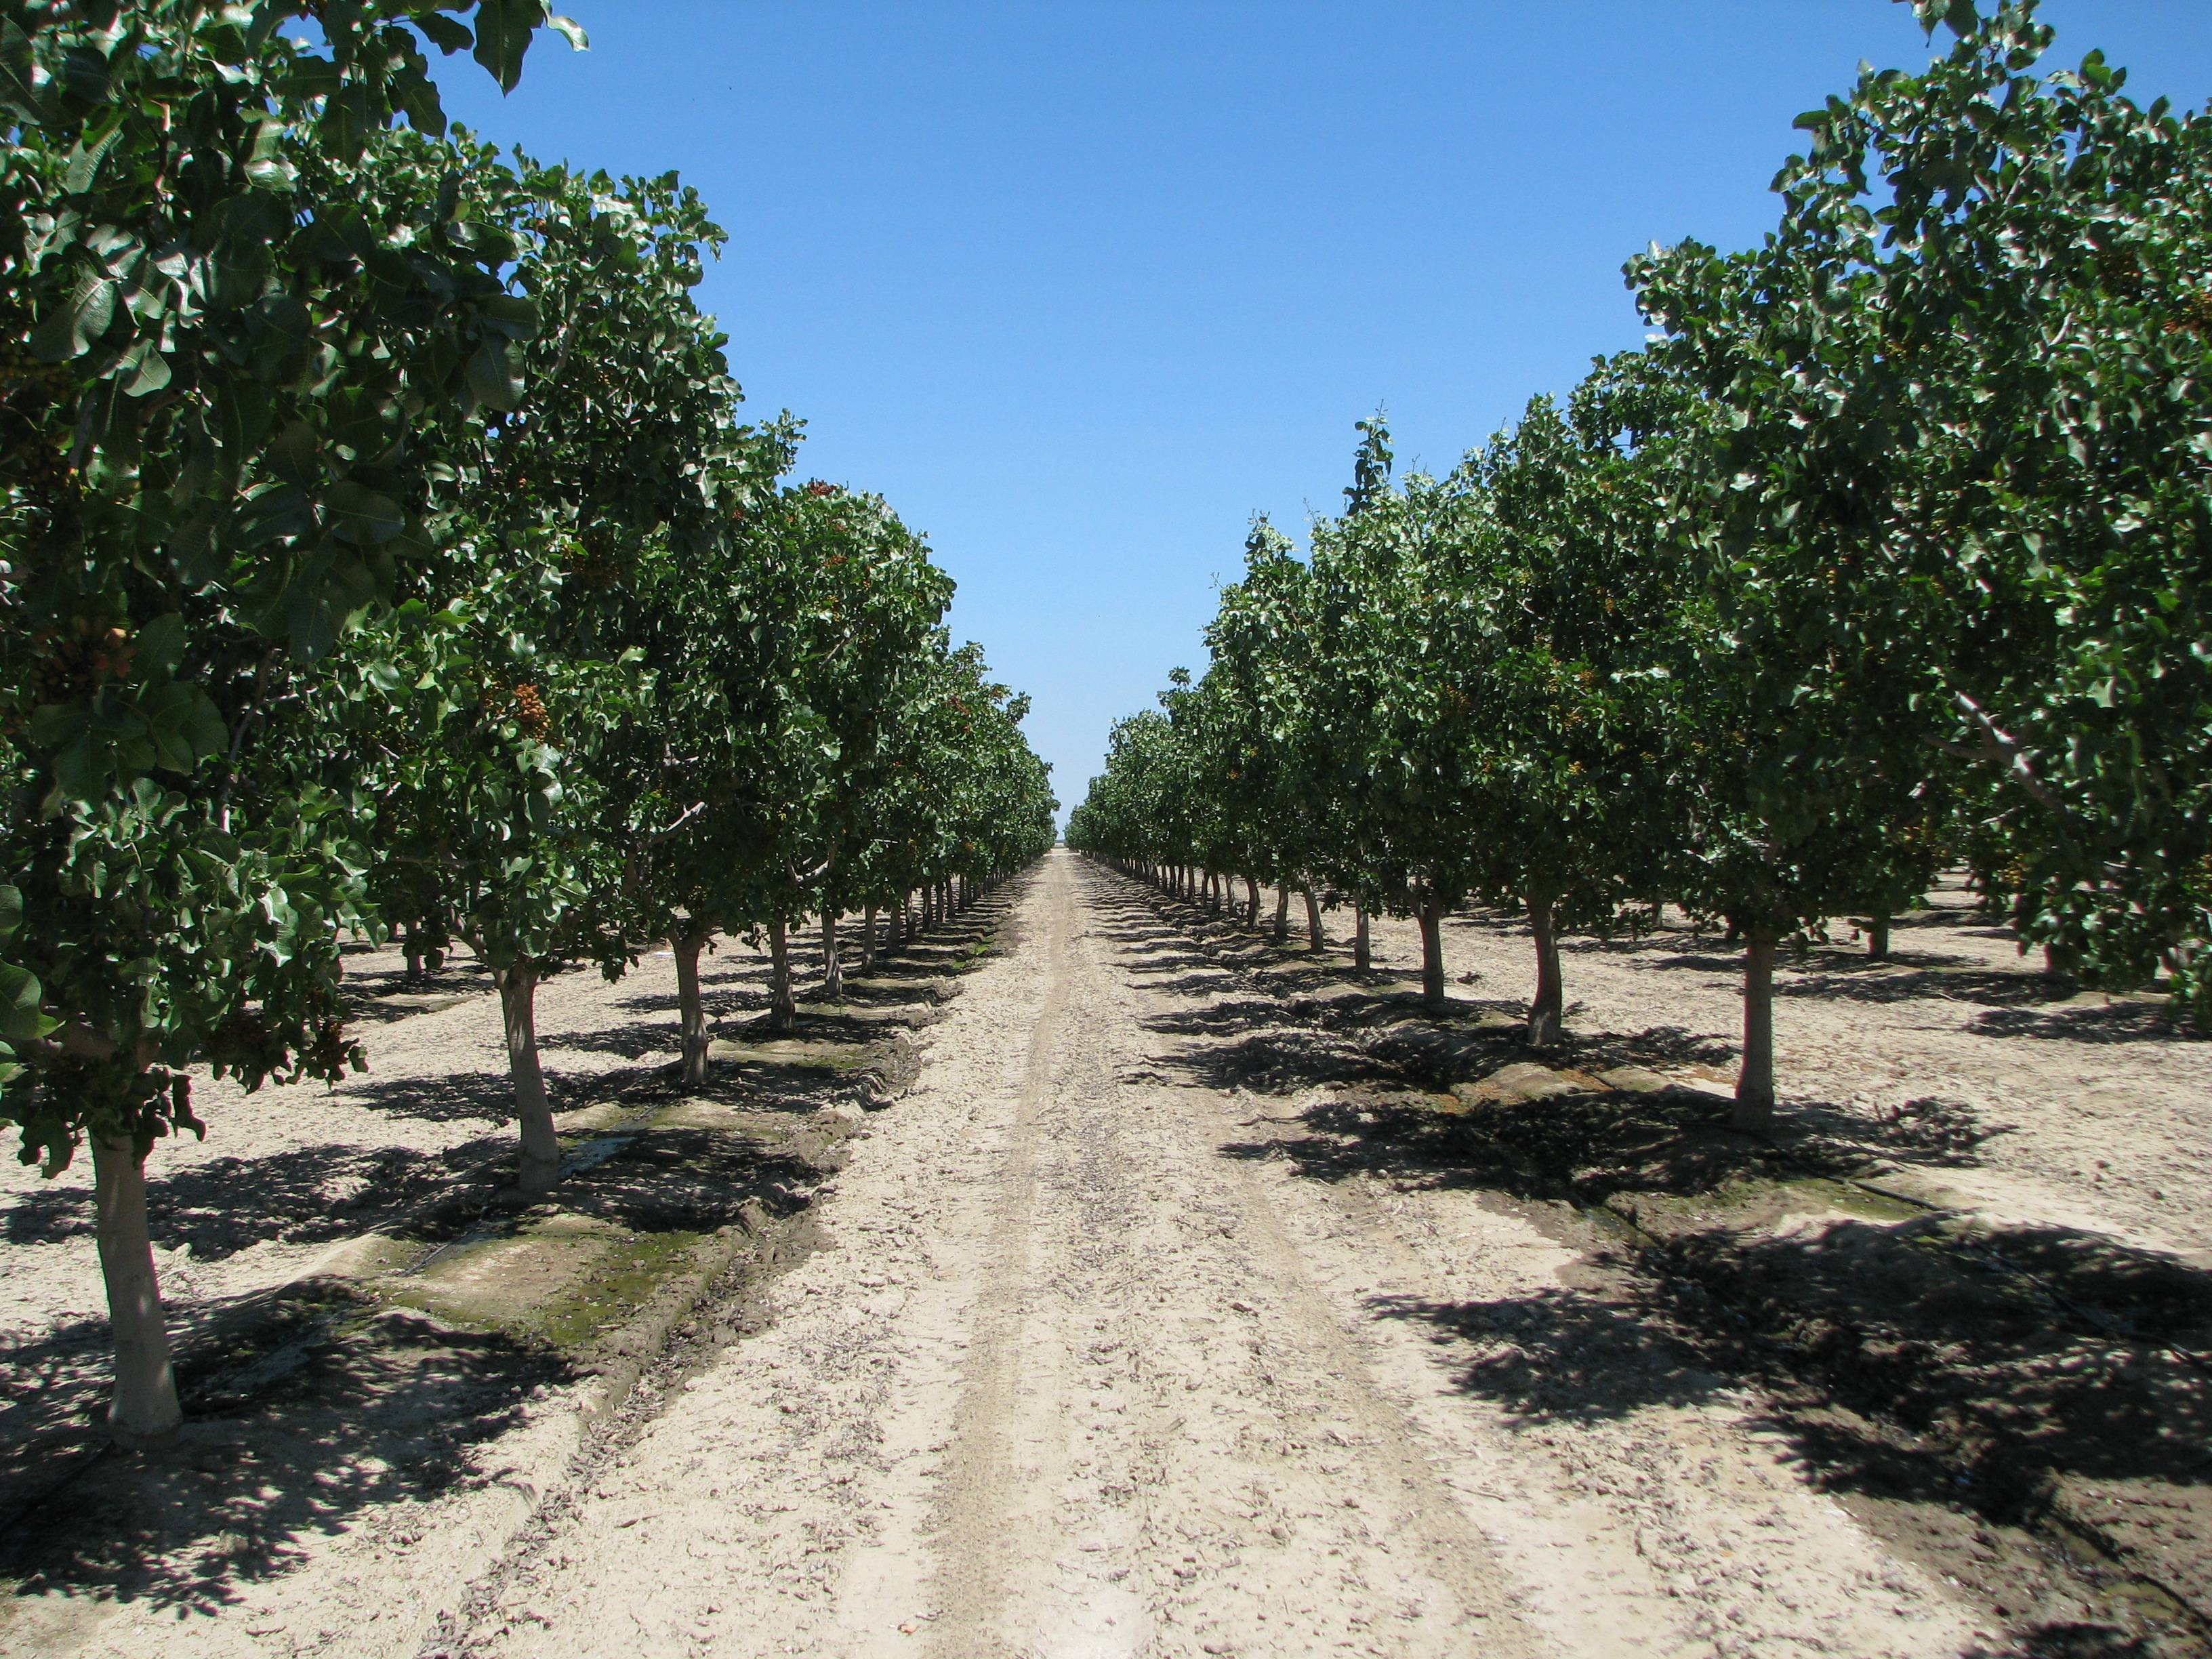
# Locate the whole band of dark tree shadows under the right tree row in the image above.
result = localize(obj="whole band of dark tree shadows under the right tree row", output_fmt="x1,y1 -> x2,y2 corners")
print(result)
1092,862 -> 2212,1659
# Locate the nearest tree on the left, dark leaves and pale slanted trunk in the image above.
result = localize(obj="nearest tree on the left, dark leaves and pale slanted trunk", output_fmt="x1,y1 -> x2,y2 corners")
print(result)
0,0 -> 581,1442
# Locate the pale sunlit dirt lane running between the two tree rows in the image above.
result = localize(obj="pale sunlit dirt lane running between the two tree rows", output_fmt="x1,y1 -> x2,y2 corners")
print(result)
431,854 -> 2008,1659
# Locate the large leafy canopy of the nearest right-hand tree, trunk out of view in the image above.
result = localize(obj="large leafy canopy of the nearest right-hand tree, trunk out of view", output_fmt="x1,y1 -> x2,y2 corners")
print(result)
1631,2 -> 2212,1119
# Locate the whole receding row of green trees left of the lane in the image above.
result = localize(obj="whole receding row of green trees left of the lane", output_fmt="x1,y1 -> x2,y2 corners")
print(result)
0,0 -> 1053,1440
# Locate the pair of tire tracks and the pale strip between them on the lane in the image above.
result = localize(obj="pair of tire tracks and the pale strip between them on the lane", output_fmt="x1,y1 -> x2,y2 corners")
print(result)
931,867 -> 1537,1659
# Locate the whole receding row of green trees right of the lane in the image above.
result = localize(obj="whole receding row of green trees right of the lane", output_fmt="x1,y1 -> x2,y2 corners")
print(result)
1069,0 -> 2212,1130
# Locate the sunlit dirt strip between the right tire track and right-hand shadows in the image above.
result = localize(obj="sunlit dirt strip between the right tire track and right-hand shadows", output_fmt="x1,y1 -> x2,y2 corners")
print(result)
1095,872 -> 1991,1659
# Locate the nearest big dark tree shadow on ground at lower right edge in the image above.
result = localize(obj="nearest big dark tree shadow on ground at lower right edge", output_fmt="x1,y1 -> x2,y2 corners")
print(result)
1631,1216 -> 2212,1652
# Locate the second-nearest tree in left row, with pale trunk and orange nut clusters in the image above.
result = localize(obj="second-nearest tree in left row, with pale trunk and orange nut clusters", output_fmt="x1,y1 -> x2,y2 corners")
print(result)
334,135 -> 743,1192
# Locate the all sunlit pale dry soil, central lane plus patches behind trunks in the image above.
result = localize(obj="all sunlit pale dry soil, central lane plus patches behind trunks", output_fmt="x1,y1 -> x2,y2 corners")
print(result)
0,852 -> 2207,1659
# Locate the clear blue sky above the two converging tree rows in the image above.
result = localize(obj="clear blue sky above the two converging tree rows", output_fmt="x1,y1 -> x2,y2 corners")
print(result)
443,0 -> 2212,827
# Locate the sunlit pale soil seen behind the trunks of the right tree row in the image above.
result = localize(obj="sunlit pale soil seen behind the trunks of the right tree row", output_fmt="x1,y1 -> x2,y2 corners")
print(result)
1327,880 -> 2212,1267
